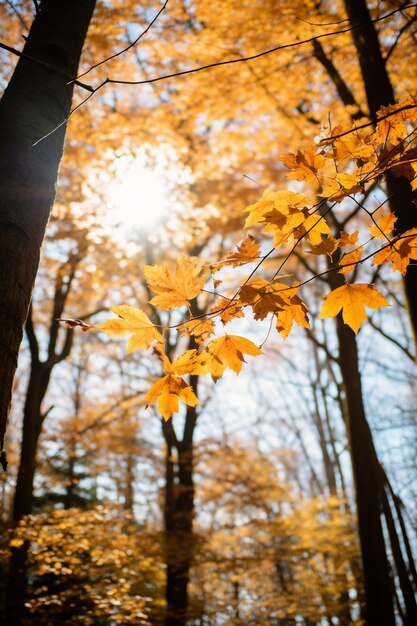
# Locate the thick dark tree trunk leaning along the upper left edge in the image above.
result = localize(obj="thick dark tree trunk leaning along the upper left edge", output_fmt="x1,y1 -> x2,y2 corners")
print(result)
0,0 -> 95,448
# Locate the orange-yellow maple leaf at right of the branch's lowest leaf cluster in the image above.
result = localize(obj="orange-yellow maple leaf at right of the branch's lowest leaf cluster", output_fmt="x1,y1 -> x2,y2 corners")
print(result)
206,335 -> 263,380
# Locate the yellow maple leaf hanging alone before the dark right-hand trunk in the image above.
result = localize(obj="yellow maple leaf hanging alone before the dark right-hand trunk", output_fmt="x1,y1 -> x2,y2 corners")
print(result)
319,284 -> 390,334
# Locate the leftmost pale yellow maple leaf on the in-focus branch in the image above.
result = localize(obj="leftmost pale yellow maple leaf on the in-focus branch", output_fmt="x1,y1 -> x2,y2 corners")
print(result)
96,304 -> 163,354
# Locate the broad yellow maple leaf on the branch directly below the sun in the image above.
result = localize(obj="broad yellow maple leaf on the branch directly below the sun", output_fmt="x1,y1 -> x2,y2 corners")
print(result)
144,256 -> 209,310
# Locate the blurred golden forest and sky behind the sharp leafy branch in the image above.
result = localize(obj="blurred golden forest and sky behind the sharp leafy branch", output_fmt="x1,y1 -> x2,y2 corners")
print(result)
0,0 -> 417,626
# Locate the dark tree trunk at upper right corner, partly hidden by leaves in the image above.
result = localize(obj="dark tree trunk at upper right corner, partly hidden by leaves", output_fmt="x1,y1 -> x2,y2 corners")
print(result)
345,0 -> 417,346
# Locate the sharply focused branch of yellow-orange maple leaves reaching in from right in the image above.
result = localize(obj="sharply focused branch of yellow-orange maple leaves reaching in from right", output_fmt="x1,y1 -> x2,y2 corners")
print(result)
62,98 -> 417,420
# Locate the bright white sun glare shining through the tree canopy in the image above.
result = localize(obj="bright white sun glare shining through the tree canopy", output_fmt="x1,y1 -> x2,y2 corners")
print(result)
106,154 -> 172,232
